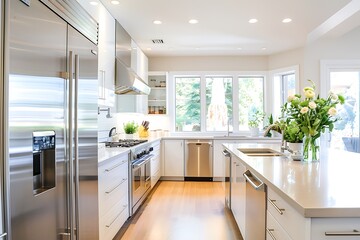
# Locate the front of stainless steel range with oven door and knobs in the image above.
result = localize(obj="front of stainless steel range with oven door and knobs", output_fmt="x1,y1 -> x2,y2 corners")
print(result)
129,144 -> 153,215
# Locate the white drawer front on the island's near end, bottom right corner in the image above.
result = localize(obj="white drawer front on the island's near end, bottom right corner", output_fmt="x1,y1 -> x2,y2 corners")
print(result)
311,218 -> 360,240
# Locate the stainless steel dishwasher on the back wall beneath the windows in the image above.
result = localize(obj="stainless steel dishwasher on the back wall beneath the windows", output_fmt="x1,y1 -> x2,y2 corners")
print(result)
185,140 -> 213,181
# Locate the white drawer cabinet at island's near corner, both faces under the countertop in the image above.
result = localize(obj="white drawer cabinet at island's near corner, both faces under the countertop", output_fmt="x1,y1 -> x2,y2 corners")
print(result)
266,187 -> 360,240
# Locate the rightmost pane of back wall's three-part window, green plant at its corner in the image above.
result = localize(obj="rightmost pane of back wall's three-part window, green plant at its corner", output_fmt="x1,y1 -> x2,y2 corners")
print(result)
238,77 -> 264,130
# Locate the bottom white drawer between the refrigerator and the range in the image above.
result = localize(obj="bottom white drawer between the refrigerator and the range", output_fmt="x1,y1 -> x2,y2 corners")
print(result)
99,197 -> 129,240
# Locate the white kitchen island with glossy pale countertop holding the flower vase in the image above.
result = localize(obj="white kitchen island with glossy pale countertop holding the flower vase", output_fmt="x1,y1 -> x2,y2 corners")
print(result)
224,144 -> 360,240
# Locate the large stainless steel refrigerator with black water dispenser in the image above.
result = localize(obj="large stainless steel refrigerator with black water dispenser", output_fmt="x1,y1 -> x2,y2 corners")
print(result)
5,0 -> 99,240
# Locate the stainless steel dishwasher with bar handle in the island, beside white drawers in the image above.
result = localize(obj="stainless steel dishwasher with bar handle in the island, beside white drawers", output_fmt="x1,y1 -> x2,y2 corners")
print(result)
243,170 -> 266,240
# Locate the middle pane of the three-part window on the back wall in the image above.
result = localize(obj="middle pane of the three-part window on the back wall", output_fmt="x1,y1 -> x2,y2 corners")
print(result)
206,77 -> 232,131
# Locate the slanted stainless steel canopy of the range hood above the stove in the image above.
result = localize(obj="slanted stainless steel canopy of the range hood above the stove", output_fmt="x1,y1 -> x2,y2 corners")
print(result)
115,59 -> 151,95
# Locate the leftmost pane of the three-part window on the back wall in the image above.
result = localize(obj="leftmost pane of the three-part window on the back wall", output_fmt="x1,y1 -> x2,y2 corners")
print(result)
175,77 -> 201,132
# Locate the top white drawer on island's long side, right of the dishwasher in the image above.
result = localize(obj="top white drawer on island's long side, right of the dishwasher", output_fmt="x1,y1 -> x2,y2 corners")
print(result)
267,188 -> 310,240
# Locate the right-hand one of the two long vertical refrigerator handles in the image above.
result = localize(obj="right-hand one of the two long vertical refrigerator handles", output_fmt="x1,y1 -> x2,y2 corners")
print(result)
74,54 -> 80,239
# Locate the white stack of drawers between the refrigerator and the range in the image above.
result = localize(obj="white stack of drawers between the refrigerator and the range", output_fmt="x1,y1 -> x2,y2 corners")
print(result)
98,154 -> 129,240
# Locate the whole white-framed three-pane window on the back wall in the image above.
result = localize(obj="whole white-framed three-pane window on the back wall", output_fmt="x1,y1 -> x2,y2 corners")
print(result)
168,72 -> 266,135
